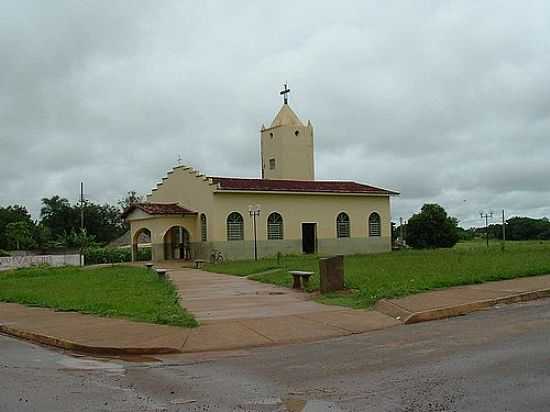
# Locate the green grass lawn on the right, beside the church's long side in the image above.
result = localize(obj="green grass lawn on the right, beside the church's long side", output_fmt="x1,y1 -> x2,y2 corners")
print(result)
206,241 -> 550,308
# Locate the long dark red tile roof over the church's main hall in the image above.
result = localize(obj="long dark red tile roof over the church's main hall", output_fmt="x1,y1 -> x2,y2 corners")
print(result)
210,177 -> 399,195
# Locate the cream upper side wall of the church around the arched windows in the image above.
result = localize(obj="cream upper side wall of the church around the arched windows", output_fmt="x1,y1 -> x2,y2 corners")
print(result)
209,193 -> 391,241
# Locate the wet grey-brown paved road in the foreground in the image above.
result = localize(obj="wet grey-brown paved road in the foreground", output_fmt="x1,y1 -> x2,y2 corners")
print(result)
0,300 -> 550,412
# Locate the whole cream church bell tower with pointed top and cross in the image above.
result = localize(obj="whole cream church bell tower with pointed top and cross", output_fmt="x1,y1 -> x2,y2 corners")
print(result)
261,84 -> 315,180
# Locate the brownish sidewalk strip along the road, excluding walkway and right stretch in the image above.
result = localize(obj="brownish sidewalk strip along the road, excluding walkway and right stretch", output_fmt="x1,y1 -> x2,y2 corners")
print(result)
0,303 -> 399,355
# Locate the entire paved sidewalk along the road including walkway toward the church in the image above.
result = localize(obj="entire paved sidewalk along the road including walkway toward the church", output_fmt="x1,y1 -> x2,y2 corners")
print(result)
0,270 -> 550,355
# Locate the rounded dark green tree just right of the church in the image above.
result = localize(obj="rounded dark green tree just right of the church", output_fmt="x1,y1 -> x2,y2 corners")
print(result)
407,203 -> 458,249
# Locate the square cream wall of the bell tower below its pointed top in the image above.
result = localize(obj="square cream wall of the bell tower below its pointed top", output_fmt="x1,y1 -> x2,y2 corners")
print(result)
261,124 -> 315,180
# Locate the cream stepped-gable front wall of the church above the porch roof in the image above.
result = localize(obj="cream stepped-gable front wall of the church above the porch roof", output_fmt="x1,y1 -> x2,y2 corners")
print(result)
147,166 -> 216,242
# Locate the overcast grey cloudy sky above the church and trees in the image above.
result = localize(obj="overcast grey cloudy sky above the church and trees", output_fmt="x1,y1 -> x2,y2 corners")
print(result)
0,0 -> 550,227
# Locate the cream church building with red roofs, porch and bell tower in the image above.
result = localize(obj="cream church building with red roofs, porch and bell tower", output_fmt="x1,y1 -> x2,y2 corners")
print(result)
124,87 -> 398,261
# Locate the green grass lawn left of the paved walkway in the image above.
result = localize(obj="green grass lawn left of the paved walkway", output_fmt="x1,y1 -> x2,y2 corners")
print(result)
0,266 -> 197,327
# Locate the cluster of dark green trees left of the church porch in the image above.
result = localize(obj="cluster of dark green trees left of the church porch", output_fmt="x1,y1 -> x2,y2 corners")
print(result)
0,191 -> 142,250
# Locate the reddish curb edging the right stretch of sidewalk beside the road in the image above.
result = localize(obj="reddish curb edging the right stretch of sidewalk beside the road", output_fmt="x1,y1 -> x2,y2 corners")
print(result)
375,288 -> 550,325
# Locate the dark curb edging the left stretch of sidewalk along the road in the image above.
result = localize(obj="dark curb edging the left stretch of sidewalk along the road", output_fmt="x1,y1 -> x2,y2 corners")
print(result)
0,324 -> 181,356
